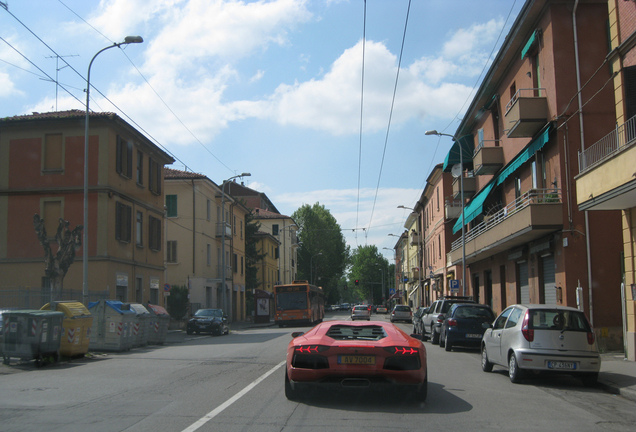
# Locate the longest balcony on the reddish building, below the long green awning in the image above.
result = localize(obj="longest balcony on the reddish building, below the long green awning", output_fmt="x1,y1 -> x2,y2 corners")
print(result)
447,189 -> 563,264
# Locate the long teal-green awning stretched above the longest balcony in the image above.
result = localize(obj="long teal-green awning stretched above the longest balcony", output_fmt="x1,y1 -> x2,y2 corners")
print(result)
453,126 -> 552,234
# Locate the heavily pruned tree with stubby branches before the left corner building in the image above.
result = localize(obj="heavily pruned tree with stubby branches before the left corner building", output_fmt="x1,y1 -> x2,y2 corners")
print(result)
33,214 -> 83,302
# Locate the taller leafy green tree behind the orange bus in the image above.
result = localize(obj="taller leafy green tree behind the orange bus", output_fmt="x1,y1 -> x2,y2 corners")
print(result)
292,203 -> 349,298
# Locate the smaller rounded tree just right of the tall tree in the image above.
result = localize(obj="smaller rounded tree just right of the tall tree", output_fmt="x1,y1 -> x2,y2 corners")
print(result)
349,245 -> 390,304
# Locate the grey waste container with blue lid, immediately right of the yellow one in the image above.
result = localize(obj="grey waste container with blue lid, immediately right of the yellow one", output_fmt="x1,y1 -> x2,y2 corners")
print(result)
88,300 -> 136,351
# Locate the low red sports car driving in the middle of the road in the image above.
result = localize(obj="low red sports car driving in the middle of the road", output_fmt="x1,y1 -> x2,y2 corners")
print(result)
285,321 -> 428,401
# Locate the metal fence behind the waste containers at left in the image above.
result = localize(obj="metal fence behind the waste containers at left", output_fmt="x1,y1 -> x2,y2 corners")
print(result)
0,287 -> 110,309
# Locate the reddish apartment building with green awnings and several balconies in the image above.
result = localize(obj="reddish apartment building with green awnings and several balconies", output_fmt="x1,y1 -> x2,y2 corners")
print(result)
444,0 -> 623,349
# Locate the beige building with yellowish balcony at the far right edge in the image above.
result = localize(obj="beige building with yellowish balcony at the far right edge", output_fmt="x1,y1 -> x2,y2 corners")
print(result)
576,0 -> 636,361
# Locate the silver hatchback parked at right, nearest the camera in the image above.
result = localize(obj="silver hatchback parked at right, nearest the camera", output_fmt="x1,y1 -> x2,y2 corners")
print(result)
481,304 -> 601,386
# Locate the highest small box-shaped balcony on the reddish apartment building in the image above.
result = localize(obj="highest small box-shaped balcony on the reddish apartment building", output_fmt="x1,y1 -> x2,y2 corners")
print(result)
505,89 -> 548,138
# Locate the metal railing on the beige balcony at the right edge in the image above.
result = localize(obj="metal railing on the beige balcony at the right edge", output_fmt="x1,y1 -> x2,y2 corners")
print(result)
579,116 -> 636,174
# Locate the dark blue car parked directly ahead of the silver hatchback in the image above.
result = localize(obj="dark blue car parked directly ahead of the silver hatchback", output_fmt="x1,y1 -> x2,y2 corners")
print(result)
439,303 -> 495,351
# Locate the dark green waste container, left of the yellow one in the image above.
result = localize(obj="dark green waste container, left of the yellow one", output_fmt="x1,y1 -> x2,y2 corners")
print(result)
2,309 -> 64,365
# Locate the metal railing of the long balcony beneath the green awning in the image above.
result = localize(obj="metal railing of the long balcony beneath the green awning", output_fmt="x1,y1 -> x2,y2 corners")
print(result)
451,189 -> 562,252
